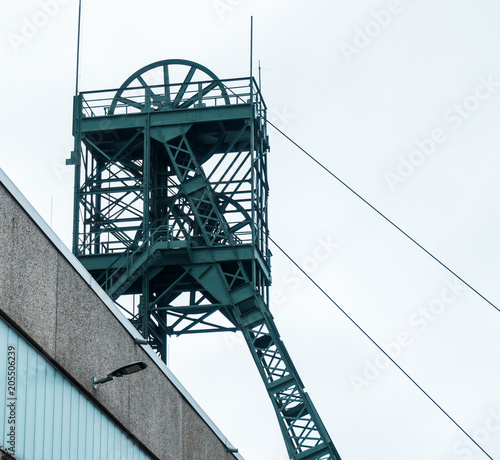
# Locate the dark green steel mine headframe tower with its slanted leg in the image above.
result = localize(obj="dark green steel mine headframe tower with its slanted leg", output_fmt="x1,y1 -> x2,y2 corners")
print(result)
68,59 -> 340,460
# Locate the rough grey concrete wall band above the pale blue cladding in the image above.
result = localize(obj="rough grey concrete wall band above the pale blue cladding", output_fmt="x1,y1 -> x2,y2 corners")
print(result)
0,170 -> 242,460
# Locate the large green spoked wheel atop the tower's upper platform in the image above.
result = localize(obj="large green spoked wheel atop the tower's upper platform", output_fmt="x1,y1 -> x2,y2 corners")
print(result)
108,59 -> 230,115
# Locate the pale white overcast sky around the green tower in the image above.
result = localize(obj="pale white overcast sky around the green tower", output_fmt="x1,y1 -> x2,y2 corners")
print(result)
0,0 -> 500,460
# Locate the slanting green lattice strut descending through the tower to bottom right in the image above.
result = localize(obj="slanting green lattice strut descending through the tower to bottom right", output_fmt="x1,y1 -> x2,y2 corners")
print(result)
157,123 -> 340,459
